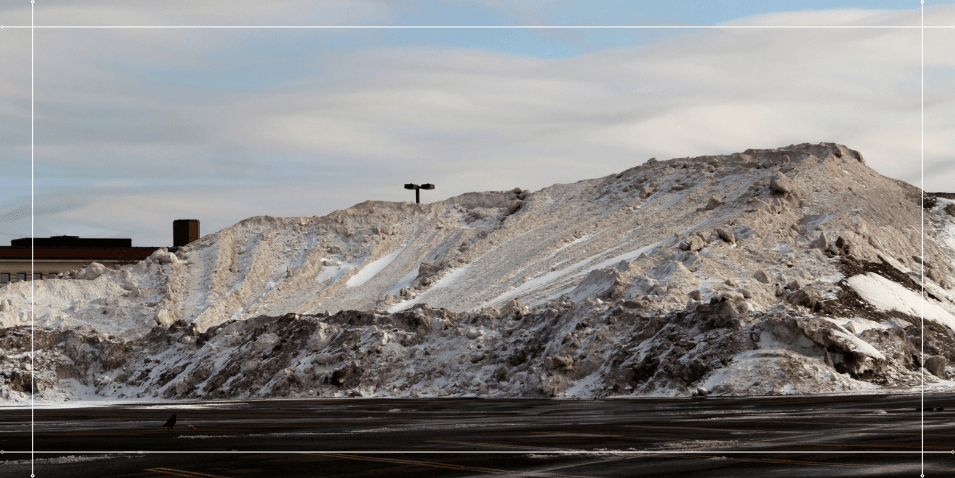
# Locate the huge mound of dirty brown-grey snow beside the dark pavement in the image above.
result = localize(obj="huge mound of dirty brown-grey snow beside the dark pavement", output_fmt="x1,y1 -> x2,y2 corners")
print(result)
0,143 -> 955,401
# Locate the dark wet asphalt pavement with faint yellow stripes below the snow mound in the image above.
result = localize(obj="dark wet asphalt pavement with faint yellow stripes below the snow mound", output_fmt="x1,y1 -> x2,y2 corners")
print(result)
0,395 -> 955,478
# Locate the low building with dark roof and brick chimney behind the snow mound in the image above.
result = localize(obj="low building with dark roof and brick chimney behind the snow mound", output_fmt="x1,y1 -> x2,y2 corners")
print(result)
0,219 -> 199,285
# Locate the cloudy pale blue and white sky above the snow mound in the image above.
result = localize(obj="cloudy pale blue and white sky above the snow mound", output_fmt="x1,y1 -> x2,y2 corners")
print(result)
0,0 -> 955,246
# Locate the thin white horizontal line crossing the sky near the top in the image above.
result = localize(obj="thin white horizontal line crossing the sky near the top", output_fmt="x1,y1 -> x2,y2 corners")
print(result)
3,25 -> 955,30
